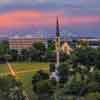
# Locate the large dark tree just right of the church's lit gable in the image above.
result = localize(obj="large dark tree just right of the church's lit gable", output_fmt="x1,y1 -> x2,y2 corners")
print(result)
70,47 -> 97,66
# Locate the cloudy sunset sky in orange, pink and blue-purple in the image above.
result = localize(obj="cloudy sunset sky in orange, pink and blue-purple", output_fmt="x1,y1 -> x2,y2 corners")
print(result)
0,0 -> 100,36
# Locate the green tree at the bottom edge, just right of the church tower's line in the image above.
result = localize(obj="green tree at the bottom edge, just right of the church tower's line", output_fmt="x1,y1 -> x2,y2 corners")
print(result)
54,80 -> 82,100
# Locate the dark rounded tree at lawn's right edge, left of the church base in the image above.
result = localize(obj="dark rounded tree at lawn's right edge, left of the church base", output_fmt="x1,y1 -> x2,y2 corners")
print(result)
32,70 -> 56,100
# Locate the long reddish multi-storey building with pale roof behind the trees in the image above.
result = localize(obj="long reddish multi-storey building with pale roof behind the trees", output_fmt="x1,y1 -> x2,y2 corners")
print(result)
8,36 -> 44,50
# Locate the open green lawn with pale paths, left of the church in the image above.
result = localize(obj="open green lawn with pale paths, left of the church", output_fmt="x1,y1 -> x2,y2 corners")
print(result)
0,62 -> 49,98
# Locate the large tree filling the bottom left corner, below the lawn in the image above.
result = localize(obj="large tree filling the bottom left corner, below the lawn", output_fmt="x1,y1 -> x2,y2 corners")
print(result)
0,76 -> 25,100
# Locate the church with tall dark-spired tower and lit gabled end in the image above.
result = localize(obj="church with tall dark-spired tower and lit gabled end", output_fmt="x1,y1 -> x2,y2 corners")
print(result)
50,17 -> 72,81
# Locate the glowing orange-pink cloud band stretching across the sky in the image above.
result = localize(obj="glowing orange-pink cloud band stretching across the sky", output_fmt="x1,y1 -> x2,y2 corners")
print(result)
0,11 -> 100,28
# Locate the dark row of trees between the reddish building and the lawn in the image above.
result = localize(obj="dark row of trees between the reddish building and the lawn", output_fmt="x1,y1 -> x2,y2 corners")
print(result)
0,41 -> 68,62
